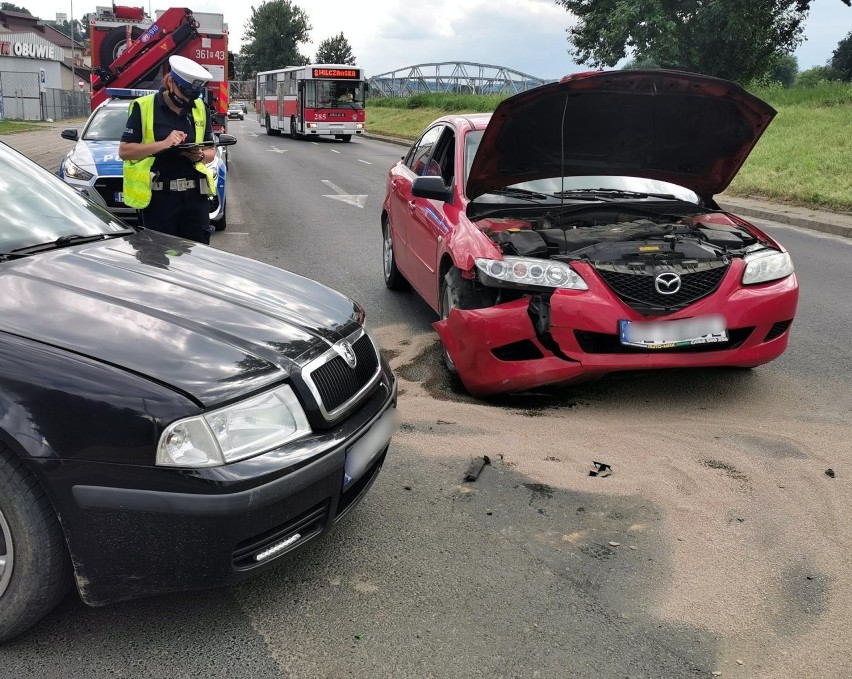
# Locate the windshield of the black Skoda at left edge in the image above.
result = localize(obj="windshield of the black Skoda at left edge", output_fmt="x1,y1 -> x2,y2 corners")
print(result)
0,142 -> 127,252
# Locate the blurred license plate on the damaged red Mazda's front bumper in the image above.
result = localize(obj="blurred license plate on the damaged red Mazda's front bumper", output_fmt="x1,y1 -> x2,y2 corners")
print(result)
619,316 -> 728,349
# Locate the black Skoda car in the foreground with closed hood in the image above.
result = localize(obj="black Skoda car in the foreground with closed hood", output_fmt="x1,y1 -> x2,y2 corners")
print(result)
0,143 -> 397,641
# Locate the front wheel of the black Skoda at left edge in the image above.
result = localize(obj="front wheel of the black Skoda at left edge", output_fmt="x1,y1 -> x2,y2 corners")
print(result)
0,447 -> 71,643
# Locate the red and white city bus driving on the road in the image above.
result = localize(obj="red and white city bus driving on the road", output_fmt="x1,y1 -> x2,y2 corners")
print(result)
256,64 -> 367,141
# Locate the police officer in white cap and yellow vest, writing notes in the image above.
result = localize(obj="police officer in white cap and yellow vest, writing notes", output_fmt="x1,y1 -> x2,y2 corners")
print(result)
118,56 -> 216,243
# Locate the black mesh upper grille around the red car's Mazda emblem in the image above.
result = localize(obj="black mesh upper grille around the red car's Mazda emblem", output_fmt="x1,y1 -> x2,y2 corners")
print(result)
595,262 -> 728,314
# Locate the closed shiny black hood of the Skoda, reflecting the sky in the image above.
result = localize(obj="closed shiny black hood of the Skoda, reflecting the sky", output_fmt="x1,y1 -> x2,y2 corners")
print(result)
0,231 -> 360,406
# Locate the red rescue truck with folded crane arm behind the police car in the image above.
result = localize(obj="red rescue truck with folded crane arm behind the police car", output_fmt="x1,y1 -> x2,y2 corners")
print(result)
89,5 -> 228,133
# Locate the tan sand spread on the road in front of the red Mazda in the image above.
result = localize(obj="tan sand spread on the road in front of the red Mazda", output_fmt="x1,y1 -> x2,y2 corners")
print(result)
375,327 -> 852,677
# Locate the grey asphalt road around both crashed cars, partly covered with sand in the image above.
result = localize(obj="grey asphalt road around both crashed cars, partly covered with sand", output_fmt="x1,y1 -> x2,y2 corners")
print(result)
0,119 -> 852,679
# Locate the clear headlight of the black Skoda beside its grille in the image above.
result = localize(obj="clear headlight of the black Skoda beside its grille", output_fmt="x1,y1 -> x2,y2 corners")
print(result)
157,386 -> 311,467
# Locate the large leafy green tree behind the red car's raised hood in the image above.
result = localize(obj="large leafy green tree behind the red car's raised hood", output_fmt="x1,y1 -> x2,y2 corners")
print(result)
555,0 -> 852,82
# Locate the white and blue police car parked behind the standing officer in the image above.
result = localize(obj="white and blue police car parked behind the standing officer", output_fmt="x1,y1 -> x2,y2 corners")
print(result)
57,88 -> 228,231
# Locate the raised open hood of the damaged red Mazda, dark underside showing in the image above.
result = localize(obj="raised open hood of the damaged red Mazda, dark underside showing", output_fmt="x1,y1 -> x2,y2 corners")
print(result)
466,70 -> 776,200
